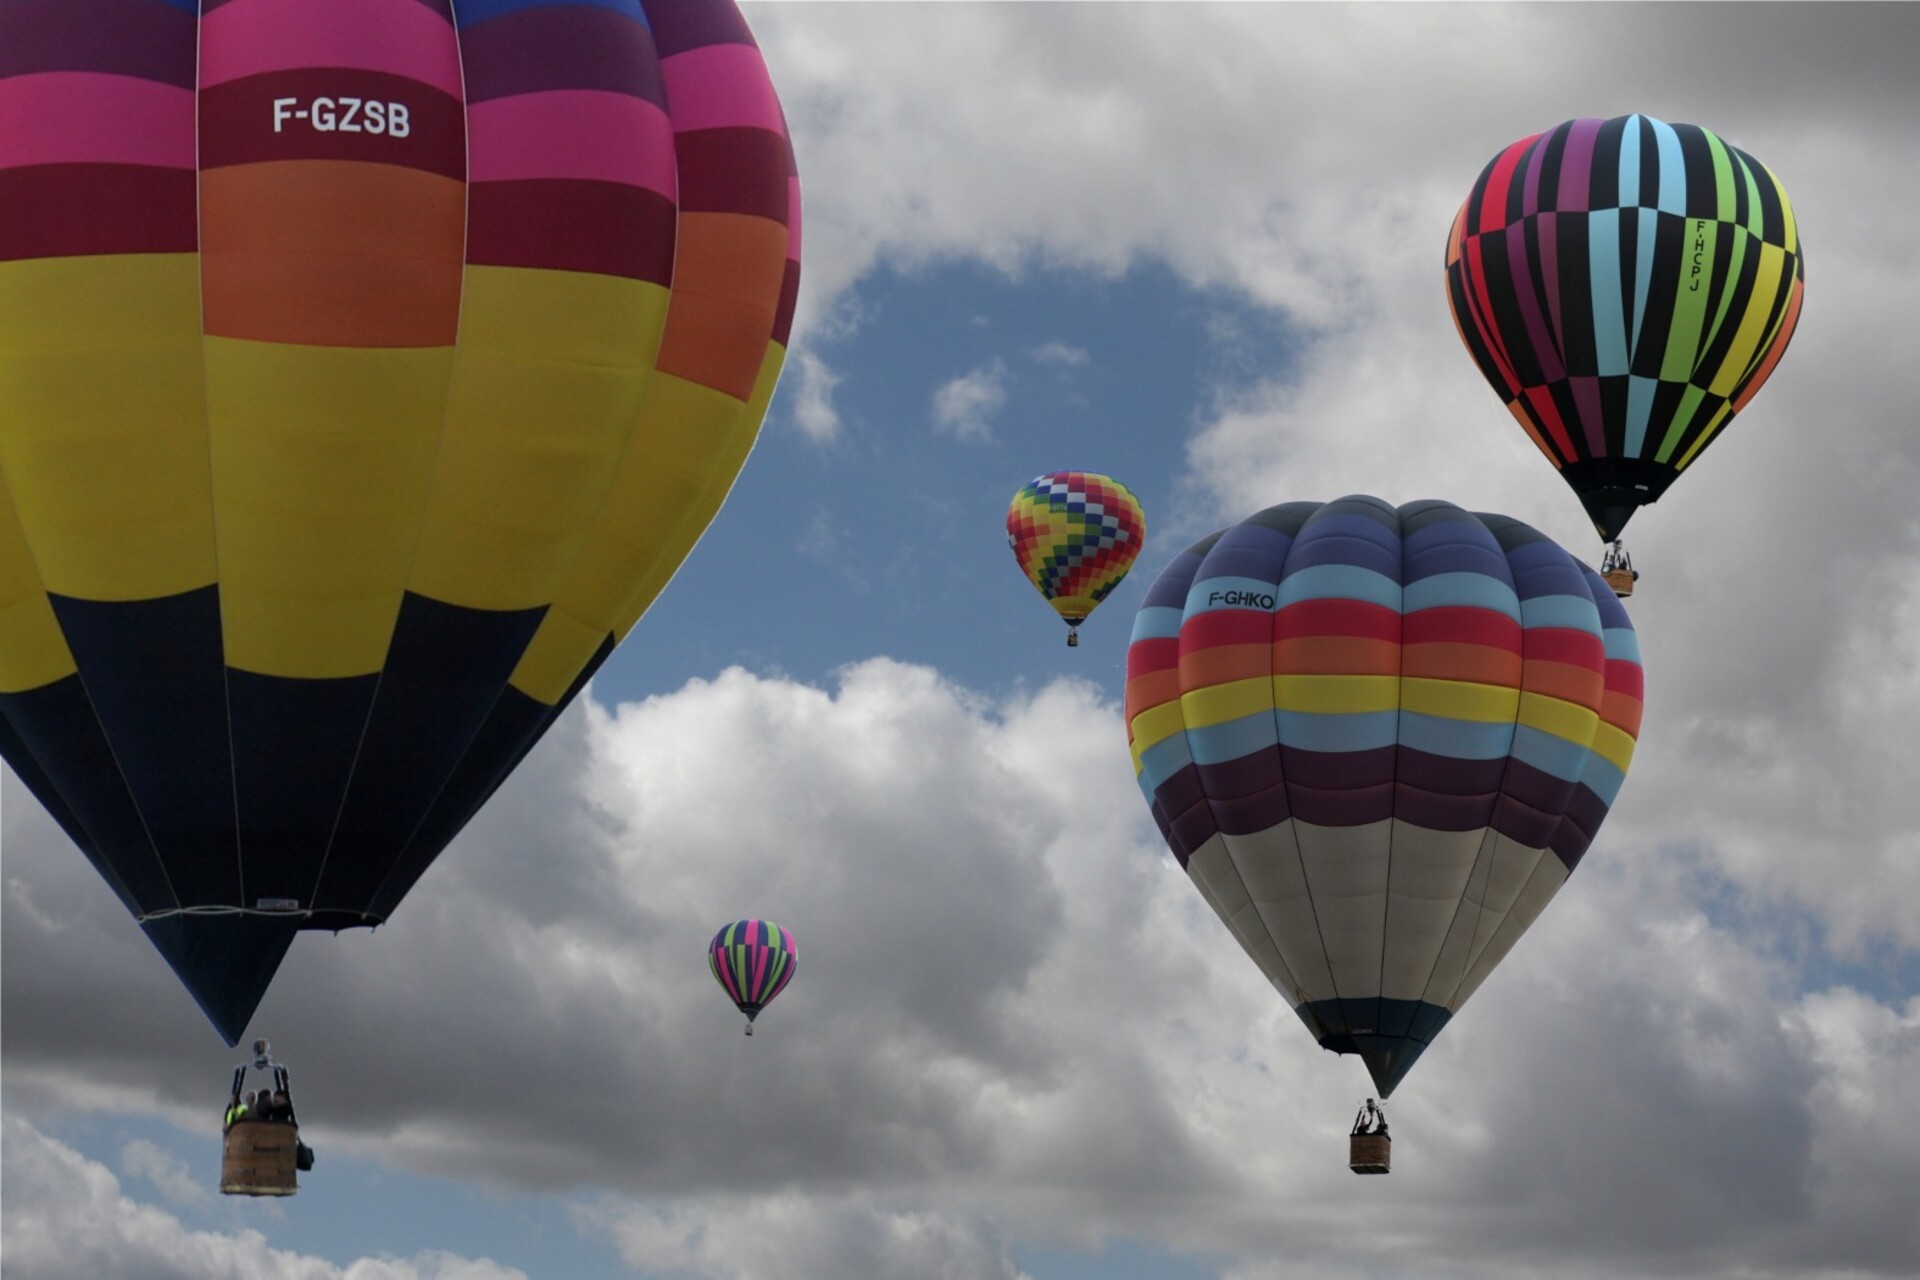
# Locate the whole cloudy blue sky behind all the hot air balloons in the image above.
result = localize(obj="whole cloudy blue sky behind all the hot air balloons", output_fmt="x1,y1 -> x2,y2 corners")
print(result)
0,4 -> 1920,1280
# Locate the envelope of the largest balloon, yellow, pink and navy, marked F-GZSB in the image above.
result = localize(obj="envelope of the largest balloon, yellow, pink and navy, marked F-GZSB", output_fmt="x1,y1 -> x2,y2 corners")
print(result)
0,0 -> 799,1044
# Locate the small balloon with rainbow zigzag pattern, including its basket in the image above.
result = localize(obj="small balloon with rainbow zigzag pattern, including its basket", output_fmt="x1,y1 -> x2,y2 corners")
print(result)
1006,470 -> 1146,645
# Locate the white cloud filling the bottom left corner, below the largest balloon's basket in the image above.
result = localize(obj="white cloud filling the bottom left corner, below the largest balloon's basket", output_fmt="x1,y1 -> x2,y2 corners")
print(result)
0,1115 -> 526,1280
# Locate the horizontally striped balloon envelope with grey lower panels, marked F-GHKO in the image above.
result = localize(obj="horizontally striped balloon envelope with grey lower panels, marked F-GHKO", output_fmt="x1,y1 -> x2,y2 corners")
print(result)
1127,497 -> 1642,1098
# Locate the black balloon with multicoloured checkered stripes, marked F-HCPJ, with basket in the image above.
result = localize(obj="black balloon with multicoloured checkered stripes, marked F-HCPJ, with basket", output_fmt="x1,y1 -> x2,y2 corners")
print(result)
1446,115 -> 1807,589
